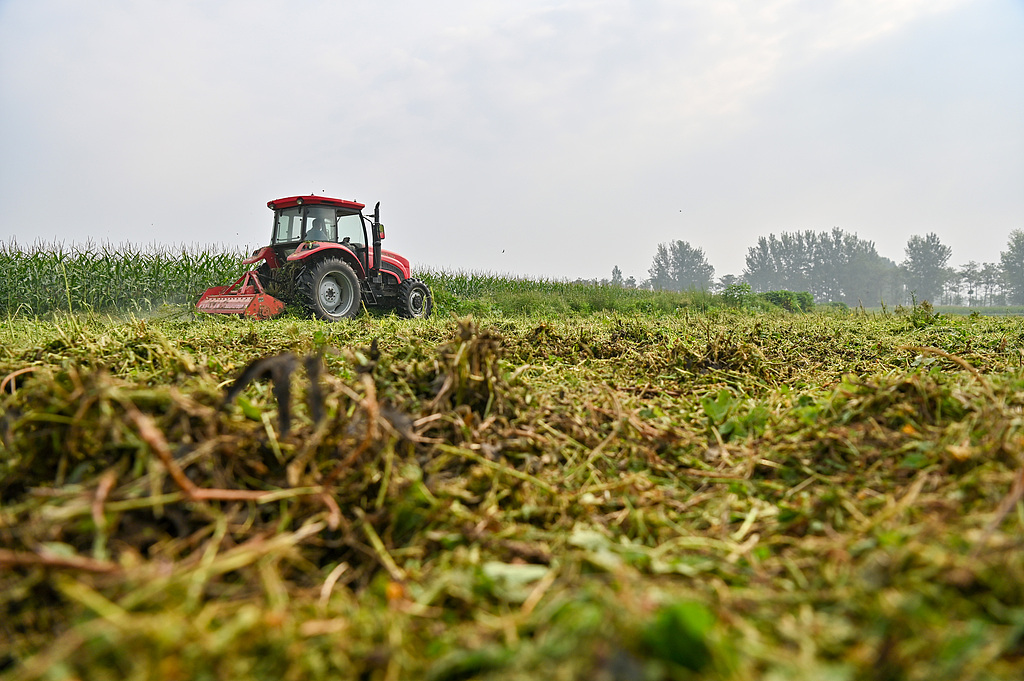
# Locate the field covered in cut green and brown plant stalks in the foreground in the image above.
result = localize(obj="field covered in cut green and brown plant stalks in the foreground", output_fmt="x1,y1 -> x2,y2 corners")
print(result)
0,308 -> 1024,681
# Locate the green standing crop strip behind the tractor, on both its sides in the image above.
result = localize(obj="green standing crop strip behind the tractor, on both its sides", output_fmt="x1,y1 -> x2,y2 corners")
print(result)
0,241 -> 710,317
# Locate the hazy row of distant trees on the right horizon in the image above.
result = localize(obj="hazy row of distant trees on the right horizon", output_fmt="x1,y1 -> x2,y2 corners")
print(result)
608,228 -> 1024,306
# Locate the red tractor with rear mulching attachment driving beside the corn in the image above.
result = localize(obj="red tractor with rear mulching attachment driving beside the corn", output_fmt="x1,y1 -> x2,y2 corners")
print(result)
197,196 -> 433,322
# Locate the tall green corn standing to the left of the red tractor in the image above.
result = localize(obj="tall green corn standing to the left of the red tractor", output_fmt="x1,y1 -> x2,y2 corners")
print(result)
0,241 -> 246,316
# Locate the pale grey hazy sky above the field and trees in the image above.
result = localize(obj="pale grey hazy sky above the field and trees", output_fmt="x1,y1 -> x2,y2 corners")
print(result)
0,0 -> 1024,280
